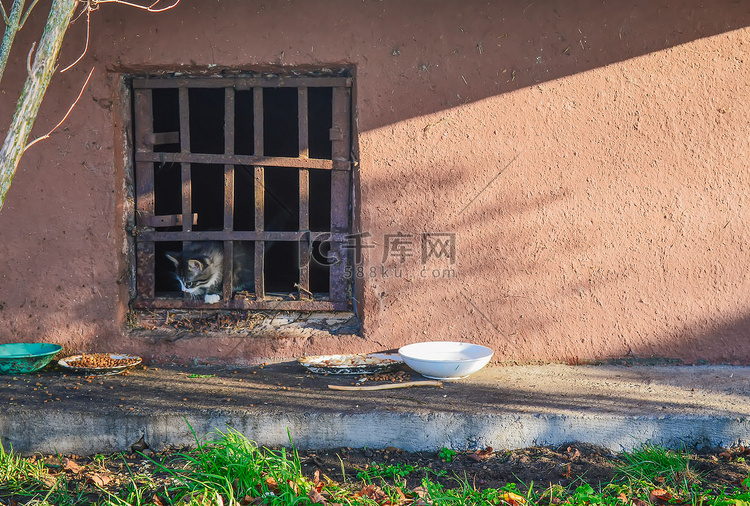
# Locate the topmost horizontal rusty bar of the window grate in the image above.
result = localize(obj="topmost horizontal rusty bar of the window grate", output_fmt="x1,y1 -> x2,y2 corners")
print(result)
133,76 -> 352,90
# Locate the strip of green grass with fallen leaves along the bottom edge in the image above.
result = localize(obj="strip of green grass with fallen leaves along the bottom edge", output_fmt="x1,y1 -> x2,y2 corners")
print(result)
0,429 -> 750,506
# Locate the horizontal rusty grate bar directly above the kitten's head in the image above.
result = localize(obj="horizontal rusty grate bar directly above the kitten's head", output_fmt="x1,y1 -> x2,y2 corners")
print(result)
138,230 -> 351,243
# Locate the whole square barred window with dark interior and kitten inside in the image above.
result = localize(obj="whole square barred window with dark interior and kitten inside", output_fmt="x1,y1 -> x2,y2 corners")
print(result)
132,73 -> 352,311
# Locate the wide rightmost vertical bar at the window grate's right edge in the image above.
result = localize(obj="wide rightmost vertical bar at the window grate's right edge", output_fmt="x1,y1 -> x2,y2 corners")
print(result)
329,87 -> 351,302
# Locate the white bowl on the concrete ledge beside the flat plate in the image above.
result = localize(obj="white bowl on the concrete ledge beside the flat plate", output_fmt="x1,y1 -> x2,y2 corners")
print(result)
398,341 -> 494,380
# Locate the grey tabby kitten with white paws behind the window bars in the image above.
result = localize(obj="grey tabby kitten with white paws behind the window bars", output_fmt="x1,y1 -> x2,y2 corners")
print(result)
166,241 -> 255,304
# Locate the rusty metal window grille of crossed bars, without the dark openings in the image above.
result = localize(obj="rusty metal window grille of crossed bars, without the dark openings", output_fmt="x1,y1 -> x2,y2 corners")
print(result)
130,74 -> 354,311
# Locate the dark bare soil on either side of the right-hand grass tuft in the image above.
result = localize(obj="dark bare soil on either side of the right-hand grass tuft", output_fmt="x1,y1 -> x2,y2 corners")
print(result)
300,443 -> 750,490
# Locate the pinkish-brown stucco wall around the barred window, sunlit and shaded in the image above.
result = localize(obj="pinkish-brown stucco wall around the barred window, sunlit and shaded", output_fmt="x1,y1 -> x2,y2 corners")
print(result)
0,0 -> 750,363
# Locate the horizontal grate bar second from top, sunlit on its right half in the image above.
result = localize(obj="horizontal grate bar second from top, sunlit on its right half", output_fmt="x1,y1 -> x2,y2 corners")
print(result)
135,151 -> 338,170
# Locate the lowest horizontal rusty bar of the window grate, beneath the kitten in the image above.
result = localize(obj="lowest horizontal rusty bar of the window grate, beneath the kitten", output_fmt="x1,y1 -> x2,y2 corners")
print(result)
133,294 -> 348,311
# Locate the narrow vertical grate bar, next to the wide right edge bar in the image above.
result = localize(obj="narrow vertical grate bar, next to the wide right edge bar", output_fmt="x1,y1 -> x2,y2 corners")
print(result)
297,86 -> 312,299
